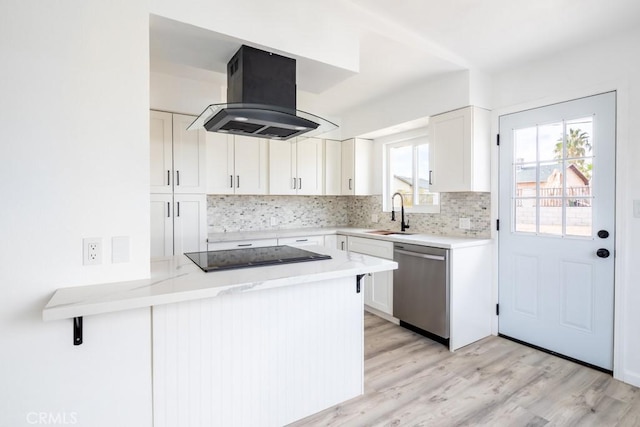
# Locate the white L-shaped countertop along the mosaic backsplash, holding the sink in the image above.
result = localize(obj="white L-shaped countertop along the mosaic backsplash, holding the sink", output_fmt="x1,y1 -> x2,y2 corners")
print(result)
208,227 -> 492,249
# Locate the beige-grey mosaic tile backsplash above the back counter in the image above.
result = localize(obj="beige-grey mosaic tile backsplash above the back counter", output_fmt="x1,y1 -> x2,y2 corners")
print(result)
207,193 -> 491,238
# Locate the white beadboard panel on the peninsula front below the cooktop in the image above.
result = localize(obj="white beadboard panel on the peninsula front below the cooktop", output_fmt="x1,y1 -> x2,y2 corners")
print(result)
153,277 -> 363,427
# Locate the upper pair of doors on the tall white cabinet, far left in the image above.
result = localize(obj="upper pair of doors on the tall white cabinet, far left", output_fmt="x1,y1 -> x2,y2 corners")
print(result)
149,111 -> 206,194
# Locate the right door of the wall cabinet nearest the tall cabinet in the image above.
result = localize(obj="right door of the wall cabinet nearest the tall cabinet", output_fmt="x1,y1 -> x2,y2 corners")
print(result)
233,135 -> 269,194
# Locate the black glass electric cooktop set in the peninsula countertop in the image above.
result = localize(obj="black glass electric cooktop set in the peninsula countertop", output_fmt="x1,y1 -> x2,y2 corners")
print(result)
185,246 -> 331,272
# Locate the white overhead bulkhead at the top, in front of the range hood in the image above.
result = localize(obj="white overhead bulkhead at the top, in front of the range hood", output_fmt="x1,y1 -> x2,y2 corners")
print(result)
151,0 -> 360,71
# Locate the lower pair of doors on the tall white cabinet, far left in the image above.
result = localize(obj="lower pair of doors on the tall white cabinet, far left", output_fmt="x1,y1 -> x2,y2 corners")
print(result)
150,194 -> 207,257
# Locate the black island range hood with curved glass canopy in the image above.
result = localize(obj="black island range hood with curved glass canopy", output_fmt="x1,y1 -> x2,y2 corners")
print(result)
188,45 -> 337,140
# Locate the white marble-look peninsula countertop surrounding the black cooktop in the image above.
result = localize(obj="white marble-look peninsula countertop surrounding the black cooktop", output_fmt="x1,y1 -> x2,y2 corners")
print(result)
42,246 -> 398,321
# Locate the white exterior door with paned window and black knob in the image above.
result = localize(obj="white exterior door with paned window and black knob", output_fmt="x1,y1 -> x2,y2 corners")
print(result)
499,92 -> 616,370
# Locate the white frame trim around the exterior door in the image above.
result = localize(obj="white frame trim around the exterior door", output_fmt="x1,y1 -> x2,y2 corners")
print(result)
491,80 -> 640,386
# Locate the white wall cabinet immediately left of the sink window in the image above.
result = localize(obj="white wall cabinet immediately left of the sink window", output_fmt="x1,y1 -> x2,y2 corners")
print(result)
340,138 -> 373,196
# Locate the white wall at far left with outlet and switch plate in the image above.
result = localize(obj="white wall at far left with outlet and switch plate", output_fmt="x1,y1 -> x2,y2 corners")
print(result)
0,0 -> 151,427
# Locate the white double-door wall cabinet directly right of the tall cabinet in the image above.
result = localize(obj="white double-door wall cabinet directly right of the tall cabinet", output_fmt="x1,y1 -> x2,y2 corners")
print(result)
206,132 -> 268,194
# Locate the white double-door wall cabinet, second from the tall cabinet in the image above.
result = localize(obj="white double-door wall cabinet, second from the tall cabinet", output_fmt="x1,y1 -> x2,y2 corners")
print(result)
269,138 -> 324,195
